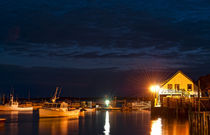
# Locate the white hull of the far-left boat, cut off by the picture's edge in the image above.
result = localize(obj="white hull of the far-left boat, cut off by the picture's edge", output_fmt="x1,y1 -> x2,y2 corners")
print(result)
0,105 -> 33,111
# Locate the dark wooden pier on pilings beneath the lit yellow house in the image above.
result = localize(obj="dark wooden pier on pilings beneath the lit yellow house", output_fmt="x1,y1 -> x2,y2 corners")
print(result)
151,97 -> 210,135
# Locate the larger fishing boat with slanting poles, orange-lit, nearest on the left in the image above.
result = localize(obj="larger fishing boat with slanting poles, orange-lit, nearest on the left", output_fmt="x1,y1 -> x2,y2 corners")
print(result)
39,87 -> 80,118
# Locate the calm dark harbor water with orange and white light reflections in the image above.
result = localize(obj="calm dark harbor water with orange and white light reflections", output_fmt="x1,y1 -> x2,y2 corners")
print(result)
0,111 -> 189,135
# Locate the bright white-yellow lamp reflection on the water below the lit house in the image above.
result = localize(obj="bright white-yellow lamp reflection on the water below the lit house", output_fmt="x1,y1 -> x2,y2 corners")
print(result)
150,118 -> 162,135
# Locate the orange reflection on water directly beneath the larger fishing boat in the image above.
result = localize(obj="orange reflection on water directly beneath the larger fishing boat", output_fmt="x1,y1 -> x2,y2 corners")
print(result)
39,118 -> 79,135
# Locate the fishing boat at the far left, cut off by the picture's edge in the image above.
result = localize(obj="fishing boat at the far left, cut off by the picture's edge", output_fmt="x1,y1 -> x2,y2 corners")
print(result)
0,94 -> 33,111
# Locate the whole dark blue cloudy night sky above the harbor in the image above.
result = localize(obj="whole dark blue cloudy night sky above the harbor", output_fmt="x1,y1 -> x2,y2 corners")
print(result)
0,0 -> 210,97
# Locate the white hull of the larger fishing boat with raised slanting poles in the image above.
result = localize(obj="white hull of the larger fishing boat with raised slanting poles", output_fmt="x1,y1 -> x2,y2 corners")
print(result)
39,109 -> 80,118
